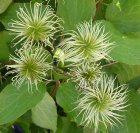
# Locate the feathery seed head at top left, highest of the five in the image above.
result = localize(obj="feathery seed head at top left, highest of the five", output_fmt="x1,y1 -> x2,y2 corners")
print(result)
8,2 -> 62,47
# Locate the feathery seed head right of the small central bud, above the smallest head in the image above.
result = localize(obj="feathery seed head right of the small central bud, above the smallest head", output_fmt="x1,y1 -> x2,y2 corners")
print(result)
58,22 -> 114,63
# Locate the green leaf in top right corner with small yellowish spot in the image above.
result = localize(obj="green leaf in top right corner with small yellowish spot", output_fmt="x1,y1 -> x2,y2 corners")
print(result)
106,0 -> 140,32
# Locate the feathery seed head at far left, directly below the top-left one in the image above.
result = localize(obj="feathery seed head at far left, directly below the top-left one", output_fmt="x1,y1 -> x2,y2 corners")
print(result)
7,46 -> 51,91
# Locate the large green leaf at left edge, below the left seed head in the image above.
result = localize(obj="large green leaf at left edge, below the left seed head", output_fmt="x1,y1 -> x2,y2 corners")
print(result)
0,84 -> 46,125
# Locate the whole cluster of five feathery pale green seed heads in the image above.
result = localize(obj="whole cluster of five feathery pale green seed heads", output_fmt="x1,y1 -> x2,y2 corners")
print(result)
8,3 -> 127,131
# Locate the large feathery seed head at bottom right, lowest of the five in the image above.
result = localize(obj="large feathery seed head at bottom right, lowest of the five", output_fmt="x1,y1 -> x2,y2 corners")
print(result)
77,75 -> 128,131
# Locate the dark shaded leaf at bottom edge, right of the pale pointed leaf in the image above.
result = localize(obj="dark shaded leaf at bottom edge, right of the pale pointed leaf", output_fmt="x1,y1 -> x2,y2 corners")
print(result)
56,117 -> 83,133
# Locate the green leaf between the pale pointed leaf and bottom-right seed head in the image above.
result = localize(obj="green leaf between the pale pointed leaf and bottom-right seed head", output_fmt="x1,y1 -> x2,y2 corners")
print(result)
56,82 -> 81,124
